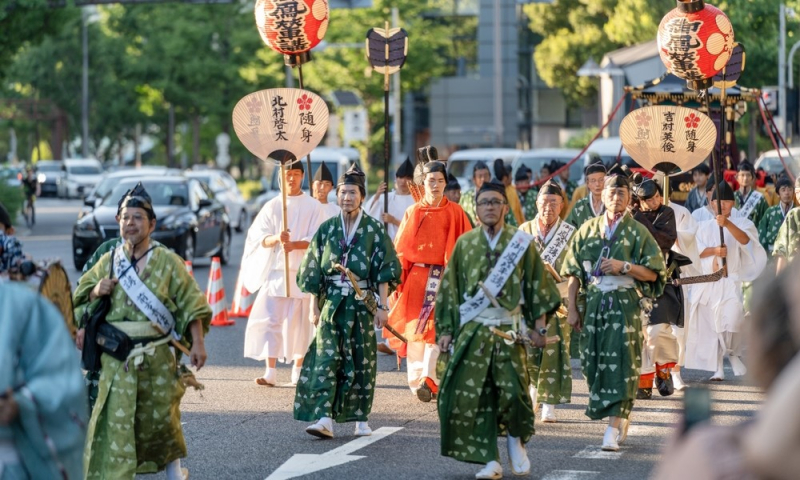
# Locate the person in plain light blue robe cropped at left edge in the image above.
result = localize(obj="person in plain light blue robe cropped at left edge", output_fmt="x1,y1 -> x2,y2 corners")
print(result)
0,281 -> 88,480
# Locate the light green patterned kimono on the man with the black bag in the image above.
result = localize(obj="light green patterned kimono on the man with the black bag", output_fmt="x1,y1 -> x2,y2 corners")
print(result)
73,246 -> 211,479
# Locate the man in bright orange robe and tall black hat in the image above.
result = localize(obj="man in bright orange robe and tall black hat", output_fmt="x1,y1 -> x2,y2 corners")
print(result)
384,161 -> 472,402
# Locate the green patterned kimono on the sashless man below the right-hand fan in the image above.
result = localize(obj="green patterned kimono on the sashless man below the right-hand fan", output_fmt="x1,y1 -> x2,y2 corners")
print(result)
561,213 -> 666,420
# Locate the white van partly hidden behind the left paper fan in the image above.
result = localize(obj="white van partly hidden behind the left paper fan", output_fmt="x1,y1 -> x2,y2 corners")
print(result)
255,147 -> 369,210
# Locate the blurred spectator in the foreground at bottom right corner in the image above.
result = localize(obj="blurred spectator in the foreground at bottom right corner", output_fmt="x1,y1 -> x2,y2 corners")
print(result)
653,262 -> 800,480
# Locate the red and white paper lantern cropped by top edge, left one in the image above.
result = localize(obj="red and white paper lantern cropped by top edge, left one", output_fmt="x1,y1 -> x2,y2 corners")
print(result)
255,0 -> 330,66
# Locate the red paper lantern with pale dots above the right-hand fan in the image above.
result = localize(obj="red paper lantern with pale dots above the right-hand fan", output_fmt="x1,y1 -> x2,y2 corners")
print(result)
658,0 -> 734,90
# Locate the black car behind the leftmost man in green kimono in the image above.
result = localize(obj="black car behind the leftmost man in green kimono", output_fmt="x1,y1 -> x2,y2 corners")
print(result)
72,177 -> 231,270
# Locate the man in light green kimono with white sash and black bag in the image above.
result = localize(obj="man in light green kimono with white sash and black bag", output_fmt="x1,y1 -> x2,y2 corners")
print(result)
73,184 -> 211,480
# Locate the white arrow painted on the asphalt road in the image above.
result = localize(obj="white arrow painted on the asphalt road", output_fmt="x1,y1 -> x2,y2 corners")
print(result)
266,427 -> 403,480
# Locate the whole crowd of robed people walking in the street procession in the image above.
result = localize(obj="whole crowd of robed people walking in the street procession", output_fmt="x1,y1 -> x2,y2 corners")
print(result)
0,147 -> 800,480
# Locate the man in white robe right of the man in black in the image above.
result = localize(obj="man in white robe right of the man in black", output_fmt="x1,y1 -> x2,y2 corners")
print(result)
685,182 -> 767,381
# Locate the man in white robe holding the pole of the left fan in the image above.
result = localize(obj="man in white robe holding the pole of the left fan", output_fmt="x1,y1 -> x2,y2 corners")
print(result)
241,158 -> 323,386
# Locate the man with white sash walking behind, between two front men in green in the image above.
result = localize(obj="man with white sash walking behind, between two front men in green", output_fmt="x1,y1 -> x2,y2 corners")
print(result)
519,180 -> 575,423
